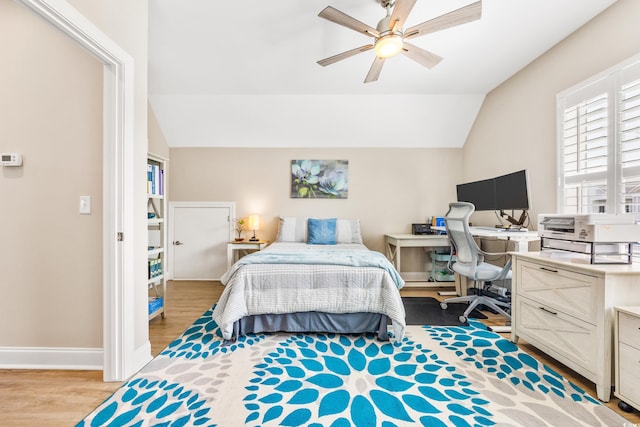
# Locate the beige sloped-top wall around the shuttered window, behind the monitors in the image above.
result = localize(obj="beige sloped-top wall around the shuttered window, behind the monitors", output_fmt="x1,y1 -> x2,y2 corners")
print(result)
462,0 -> 640,227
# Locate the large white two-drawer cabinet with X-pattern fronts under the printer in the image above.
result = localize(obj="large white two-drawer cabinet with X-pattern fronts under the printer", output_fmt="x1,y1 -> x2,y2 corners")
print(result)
511,252 -> 640,402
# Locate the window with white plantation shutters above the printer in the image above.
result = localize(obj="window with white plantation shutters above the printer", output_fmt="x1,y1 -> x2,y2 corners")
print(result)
557,55 -> 640,222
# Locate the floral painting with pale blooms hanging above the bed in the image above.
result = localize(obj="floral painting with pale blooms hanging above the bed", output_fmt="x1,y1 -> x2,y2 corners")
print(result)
291,160 -> 349,199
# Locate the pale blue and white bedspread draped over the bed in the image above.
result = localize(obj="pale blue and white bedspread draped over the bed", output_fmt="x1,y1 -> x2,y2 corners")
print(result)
213,243 -> 405,340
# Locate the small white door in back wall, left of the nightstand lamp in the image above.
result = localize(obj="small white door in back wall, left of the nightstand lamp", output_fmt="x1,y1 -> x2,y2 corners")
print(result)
169,202 -> 235,280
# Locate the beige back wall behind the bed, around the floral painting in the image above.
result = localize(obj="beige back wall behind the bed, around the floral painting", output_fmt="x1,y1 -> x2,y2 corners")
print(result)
168,148 -> 462,264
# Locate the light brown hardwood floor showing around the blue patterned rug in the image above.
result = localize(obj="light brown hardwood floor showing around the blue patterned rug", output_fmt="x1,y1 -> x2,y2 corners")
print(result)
0,281 -> 640,427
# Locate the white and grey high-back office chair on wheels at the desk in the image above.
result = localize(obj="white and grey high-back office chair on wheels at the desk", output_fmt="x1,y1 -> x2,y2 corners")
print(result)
440,202 -> 511,324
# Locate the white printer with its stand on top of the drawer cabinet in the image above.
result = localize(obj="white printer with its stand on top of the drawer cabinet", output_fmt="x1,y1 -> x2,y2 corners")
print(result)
538,213 -> 640,264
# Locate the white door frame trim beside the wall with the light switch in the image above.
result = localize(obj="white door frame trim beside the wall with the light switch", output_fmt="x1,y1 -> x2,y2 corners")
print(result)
17,0 -> 141,381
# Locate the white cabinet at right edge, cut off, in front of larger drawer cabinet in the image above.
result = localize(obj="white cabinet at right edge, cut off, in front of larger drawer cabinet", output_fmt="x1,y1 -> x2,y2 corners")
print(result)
614,306 -> 640,409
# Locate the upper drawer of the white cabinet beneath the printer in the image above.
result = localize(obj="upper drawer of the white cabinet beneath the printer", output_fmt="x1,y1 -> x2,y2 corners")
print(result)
516,261 -> 599,325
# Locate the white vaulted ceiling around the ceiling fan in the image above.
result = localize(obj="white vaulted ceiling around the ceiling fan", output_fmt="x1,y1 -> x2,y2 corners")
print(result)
149,0 -> 615,147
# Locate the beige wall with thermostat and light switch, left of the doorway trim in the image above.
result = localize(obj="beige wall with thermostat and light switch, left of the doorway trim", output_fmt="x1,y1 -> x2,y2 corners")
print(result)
0,0 -> 103,348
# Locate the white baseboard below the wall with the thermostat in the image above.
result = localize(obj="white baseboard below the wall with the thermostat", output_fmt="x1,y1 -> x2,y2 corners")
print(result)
0,347 -> 103,371
